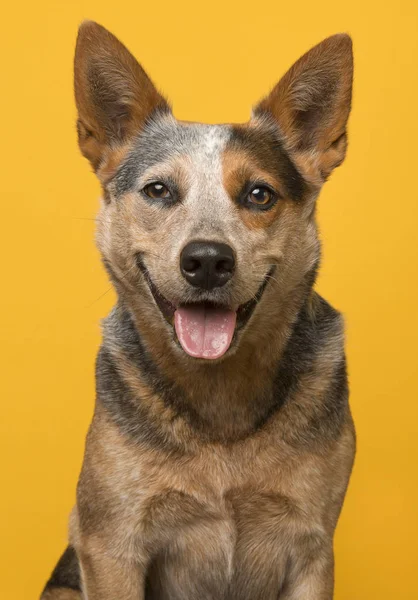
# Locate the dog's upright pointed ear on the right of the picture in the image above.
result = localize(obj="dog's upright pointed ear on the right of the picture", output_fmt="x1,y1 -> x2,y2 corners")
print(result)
253,34 -> 353,180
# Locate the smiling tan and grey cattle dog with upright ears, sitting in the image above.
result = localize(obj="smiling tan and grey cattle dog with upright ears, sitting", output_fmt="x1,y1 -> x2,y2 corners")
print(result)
42,21 -> 355,600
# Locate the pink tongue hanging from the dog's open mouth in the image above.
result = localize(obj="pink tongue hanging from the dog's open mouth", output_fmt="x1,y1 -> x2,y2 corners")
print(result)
174,306 -> 237,359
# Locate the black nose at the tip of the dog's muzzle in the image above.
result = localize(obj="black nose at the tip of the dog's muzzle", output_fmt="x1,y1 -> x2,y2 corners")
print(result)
180,242 -> 235,290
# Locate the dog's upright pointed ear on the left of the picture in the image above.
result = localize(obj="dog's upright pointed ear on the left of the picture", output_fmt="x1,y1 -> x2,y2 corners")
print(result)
74,21 -> 169,170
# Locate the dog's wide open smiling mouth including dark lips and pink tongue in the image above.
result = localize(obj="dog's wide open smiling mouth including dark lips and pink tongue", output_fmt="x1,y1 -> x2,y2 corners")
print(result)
137,256 -> 275,360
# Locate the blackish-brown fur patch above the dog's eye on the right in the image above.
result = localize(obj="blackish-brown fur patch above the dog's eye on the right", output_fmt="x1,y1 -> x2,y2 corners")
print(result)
226,123 -> 306,201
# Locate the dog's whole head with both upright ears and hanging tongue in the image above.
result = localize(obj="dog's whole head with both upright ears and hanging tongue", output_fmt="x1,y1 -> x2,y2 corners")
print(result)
75,22 -> 352,359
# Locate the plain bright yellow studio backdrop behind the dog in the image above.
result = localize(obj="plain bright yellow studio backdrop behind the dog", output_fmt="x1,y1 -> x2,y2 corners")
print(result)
0,0 -> 418,600
